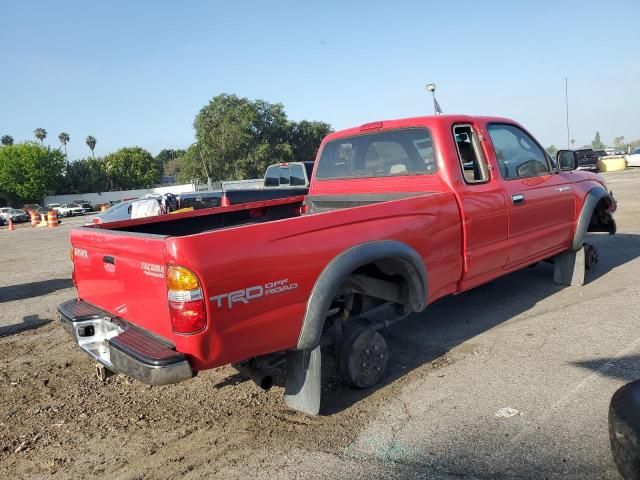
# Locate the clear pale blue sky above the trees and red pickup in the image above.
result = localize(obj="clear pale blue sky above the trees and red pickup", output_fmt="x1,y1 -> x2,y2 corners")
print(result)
0,0 -> 640,159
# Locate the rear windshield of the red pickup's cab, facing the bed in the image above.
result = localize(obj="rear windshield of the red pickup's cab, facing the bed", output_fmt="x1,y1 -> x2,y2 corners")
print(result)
316,128 -> 436,180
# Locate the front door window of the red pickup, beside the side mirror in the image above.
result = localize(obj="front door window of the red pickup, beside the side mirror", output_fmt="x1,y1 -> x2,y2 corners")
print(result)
487,123 -> 551,180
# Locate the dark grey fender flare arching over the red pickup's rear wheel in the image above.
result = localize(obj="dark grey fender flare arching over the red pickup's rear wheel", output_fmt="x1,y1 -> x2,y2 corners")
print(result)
296,240 -> 428,350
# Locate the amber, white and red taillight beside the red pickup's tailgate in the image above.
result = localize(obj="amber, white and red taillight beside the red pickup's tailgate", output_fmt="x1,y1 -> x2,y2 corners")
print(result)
167,265 -> 207,335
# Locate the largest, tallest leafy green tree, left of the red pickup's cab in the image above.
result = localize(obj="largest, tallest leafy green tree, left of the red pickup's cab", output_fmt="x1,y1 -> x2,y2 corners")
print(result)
194,94 -> 293,180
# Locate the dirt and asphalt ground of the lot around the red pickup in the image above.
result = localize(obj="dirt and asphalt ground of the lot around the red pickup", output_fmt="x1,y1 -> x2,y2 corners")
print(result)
0,169 -> 640,479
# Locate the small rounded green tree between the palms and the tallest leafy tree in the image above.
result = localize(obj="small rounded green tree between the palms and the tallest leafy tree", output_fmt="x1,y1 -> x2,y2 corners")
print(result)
104,147 -> 162,190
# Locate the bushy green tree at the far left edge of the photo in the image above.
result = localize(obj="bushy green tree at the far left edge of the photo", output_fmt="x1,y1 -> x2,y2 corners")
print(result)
0,142 -> 65,202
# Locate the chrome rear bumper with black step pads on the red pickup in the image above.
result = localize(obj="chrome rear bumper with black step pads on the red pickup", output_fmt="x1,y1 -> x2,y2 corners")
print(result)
58,300 -> 195,385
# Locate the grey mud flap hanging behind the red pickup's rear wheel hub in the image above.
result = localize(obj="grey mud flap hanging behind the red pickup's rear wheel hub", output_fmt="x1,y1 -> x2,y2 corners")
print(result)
284,345 -> 321,415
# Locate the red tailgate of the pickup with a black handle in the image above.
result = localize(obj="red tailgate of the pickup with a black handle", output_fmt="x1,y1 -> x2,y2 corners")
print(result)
71,227 -> 171,338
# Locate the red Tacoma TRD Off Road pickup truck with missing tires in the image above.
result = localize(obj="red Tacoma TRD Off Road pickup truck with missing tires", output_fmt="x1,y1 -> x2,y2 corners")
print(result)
58,115 -> 616,414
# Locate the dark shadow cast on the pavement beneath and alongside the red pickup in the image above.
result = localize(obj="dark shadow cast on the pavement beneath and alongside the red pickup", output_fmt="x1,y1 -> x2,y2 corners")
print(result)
321,234 -> 640,415
